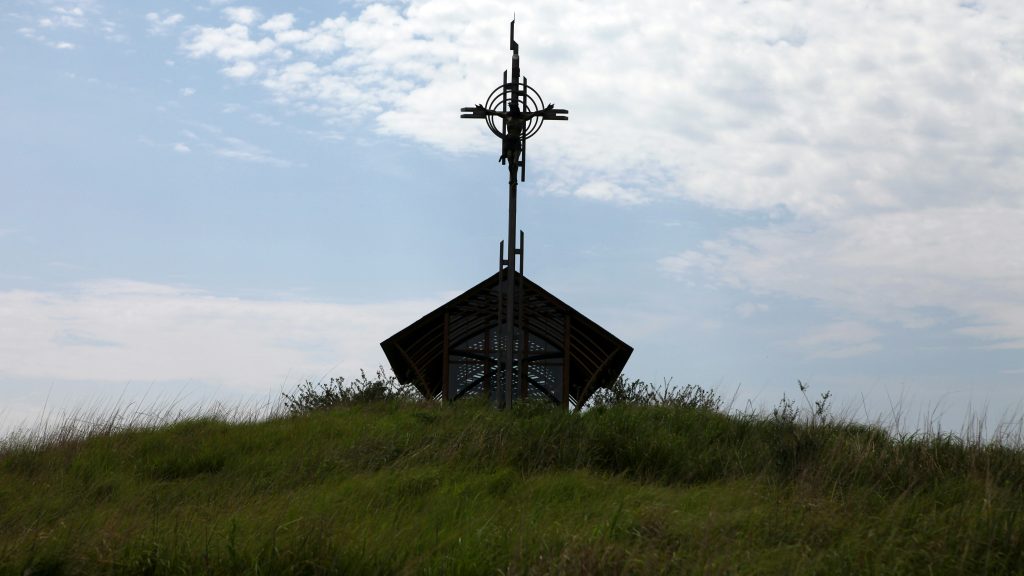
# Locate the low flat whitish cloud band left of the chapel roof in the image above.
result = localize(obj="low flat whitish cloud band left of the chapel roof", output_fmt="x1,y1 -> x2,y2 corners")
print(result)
0,280 -> 437,392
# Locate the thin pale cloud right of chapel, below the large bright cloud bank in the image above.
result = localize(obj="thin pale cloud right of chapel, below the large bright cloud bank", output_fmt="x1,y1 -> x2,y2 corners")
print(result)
660,204 -> 1024,348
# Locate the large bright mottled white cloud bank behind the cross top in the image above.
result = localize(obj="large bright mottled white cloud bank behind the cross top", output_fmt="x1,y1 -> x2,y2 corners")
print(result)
172,0 -> 1024,216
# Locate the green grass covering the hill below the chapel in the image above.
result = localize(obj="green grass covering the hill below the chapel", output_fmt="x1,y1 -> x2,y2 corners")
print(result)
0,401 -> 1024,575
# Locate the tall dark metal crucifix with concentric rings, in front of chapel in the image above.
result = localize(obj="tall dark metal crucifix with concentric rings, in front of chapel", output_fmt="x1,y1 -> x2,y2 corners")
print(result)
462,19 -> 568,408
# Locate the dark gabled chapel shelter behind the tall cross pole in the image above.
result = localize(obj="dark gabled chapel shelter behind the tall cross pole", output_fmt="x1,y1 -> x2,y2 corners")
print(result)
381,273 -> 633,408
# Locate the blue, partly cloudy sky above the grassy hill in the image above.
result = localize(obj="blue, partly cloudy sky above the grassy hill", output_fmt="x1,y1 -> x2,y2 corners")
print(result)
0,0 -> 1024,430
